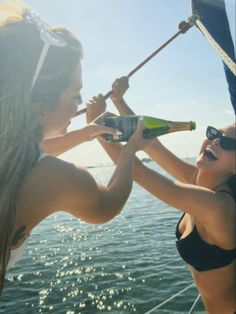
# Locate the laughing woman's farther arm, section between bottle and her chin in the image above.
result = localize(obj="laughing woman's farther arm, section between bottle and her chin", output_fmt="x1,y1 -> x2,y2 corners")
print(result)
145,139 -> 197,184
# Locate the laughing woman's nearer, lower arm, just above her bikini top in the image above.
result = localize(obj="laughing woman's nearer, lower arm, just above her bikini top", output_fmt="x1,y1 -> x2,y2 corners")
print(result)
134,163 -> 225,225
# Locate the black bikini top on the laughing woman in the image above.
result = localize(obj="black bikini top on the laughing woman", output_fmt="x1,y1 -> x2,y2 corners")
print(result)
176,214 -> 236,271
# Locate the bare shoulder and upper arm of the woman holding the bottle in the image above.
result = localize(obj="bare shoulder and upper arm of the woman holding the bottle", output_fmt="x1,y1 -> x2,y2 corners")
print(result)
16,156 -> 103,230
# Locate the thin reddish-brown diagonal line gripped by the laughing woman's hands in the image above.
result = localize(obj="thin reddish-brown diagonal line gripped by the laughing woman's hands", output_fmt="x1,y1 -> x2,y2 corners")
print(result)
75,16 -> 194,117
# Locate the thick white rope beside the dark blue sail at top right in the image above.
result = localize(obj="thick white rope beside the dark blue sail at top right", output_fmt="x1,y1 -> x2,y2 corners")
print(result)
195,18 -> 236,76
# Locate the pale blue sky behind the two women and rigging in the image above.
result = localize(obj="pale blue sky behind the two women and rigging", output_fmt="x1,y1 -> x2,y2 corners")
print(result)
26,0 -> 235,165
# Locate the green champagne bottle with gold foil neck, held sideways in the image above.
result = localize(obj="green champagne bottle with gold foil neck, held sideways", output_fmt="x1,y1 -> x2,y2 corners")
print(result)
103,115 -> 196,142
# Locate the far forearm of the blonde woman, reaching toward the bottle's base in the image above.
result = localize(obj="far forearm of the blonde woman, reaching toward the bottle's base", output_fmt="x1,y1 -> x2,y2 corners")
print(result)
41,129 -> 88,157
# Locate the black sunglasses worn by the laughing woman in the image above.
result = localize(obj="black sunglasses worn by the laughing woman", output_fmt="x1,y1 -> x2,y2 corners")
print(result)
206,126 -> 236,151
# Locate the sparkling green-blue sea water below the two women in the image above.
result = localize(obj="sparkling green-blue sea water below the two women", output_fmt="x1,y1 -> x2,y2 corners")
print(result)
0,162 -> 204,314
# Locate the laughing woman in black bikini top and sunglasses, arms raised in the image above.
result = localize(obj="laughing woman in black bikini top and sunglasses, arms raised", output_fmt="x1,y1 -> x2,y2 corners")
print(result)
87,77 -> 236,314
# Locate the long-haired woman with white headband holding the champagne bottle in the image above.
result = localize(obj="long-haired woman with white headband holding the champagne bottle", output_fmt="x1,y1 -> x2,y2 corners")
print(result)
0,0 -> 147,290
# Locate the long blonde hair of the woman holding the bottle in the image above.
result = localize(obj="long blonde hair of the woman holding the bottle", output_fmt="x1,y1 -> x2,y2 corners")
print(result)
0,20 -> 82,291
